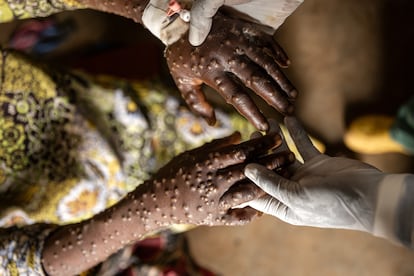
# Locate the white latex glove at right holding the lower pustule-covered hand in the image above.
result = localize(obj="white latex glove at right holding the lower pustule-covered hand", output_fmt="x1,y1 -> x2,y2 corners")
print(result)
245,117 -> 412,238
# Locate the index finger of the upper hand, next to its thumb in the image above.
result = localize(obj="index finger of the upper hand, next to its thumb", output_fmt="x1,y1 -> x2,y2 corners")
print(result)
211,74 -> 269,131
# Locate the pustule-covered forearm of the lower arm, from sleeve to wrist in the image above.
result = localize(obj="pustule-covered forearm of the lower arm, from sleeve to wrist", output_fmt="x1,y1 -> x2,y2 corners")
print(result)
43,182 -> 168,275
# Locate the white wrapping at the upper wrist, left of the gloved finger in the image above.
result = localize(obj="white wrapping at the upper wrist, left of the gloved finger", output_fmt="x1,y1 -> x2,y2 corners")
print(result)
142,0 -> 190,45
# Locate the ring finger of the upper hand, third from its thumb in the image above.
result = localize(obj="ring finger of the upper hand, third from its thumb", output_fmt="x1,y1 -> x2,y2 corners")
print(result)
246,47 -> 298,100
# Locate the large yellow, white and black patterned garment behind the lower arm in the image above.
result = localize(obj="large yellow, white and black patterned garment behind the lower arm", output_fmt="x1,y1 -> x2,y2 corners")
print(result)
0,51 -> 253,273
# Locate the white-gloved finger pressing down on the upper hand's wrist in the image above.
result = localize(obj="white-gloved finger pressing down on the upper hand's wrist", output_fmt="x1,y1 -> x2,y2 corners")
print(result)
188,0 -> 224,46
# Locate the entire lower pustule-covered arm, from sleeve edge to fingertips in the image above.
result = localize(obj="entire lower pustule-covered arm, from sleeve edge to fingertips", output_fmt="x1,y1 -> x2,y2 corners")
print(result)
42,132 -> 294,275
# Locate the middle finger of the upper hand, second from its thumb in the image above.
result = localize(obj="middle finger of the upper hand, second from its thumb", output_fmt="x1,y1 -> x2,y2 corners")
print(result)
229,56 -> 293,114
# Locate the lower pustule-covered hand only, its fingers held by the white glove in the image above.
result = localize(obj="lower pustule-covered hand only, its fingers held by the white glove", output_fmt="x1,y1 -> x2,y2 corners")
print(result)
148,133 -> 293,225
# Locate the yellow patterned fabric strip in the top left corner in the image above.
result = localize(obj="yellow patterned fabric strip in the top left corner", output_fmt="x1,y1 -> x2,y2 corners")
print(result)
0,0 -> 83,22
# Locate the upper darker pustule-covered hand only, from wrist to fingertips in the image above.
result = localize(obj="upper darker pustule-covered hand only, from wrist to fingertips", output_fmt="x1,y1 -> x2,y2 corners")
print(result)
165,14 -> 297,130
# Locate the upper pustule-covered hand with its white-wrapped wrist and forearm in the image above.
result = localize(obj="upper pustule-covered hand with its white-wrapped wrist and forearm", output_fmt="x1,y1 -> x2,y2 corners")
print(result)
78,0 -> 298,131
